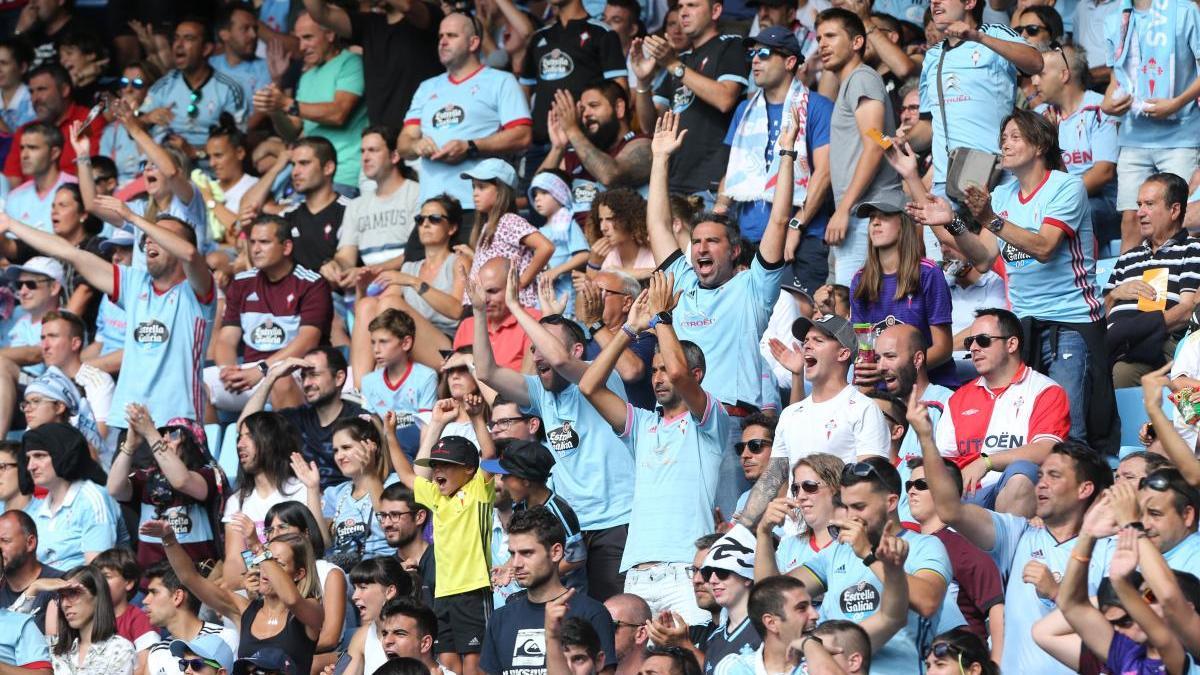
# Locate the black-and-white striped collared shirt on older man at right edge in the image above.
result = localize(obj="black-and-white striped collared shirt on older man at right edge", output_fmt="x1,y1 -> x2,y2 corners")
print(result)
1104,228 -> 1200,325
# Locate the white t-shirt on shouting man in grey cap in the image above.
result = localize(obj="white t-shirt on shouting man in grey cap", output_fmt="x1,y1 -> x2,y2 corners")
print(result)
770,384 -> 892,468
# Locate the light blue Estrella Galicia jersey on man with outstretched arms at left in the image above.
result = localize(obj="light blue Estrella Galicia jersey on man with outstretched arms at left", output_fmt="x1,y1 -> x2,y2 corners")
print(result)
108,260 -> 217,429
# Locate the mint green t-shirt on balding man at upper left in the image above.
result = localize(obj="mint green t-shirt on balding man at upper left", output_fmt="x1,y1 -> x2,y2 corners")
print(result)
296,49 -> 367,186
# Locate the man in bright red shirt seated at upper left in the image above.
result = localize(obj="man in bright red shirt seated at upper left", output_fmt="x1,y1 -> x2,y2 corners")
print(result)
4,64 -> 104,186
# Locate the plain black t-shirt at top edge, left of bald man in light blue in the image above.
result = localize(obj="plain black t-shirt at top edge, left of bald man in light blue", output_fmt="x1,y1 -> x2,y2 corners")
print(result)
349,10 -> 443,129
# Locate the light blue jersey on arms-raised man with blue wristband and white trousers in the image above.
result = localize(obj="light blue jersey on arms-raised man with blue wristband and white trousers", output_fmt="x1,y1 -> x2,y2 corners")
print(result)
620,395 -> 733,572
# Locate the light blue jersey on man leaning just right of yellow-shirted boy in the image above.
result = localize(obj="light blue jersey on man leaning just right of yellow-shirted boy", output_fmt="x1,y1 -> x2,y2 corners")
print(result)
523,370 -> 638,530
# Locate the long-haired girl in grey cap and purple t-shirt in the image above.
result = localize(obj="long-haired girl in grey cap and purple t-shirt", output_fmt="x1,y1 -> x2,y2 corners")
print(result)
850,203 -> 958,387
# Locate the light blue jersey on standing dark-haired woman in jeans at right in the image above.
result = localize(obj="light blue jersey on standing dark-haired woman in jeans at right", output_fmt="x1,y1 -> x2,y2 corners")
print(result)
991,171 -> 1103,323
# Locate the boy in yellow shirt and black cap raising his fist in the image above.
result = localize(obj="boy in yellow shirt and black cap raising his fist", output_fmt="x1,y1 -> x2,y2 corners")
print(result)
391,399 -> 496,675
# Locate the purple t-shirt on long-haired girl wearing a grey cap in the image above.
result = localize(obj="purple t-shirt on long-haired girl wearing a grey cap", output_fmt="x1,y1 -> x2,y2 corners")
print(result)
850,258 -> 959,388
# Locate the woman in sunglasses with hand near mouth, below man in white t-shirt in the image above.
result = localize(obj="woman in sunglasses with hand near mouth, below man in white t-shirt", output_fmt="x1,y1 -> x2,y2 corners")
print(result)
755,453 -> 845,571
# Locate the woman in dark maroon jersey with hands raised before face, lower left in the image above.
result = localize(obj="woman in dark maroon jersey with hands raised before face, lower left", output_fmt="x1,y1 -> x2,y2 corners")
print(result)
108,404 -> 229,568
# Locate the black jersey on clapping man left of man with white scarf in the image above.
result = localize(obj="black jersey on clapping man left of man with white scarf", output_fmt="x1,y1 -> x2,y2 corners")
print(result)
654,35 -> 749,193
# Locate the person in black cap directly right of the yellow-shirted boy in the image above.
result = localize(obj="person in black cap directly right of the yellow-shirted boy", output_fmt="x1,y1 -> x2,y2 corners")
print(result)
479,441 -> 588,593
